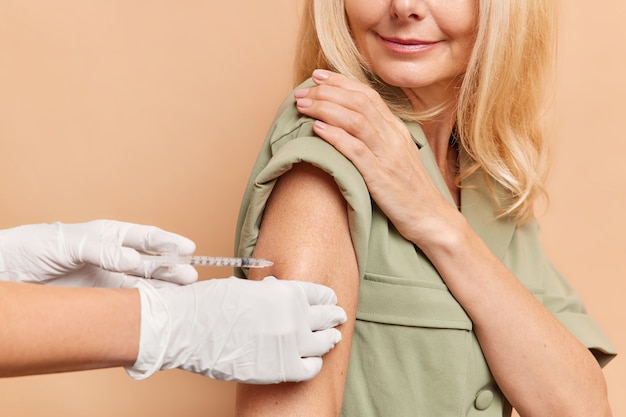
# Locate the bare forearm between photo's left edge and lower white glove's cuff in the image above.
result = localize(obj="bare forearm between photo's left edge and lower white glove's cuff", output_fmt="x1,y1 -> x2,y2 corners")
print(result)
0,282 -> 140,377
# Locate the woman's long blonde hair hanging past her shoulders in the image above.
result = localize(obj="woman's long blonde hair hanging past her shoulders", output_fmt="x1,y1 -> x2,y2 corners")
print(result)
294,0 -> 556,222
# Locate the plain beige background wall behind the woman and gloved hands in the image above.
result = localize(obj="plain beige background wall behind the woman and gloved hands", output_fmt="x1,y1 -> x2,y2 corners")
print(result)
0,0 -> 626,417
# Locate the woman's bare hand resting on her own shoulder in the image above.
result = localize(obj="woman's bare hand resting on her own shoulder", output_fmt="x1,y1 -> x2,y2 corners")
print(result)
295,70 -> 452,245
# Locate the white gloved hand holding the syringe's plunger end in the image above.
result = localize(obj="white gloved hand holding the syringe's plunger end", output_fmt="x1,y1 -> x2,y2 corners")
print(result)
0,220 -> 198,287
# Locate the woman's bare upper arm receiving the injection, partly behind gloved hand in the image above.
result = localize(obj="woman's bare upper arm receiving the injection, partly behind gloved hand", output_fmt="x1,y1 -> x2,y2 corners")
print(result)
237,163 -> 358,417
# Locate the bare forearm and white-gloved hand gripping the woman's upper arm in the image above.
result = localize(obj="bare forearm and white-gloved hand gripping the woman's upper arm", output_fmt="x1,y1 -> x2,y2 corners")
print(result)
0,270 -> 345,384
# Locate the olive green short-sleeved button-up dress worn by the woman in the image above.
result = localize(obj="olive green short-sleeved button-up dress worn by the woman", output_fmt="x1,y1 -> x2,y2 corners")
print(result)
236,79 -> 615,417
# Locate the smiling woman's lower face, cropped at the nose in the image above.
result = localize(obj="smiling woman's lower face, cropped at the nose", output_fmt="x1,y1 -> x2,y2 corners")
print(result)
345,0 -> 478,97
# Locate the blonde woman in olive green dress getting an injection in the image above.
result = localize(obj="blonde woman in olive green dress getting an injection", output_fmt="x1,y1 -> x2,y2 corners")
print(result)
237,0 -> 614,417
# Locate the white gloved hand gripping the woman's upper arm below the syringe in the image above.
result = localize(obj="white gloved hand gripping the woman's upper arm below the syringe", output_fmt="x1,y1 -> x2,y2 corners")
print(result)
126,277 -> 346,384
